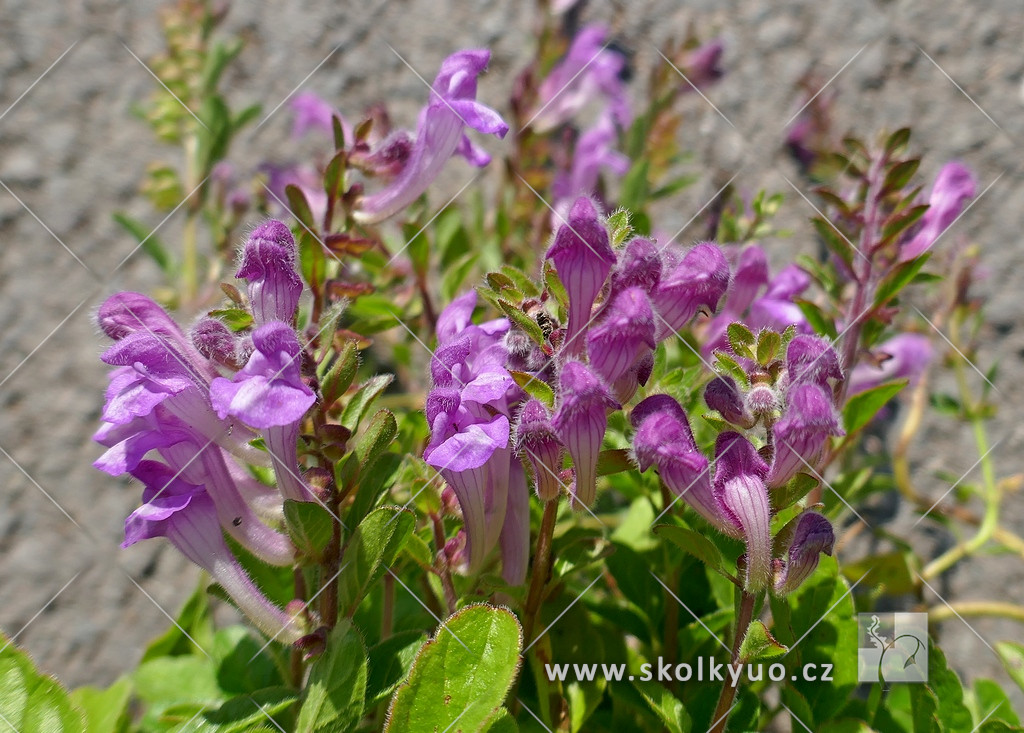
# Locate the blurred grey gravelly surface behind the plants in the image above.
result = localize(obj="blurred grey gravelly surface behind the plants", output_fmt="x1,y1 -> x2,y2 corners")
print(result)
0,0 -> 1024,708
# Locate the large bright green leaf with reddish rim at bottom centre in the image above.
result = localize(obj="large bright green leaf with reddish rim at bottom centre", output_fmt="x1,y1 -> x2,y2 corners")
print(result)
384,604 -> 522,733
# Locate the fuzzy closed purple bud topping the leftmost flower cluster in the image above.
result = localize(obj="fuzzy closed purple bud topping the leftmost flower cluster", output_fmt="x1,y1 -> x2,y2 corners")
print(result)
234,219 -> 302,326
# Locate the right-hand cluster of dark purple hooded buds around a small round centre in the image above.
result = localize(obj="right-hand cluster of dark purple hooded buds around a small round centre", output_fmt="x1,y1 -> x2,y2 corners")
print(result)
630,335 -> 843,594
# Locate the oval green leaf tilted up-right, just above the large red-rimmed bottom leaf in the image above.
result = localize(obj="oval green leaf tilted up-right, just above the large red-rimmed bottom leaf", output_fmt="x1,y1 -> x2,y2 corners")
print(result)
338,507 -> 416,616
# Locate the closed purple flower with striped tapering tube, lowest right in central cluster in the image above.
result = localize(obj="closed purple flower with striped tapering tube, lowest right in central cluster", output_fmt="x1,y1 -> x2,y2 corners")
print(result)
551,360 -> 620,507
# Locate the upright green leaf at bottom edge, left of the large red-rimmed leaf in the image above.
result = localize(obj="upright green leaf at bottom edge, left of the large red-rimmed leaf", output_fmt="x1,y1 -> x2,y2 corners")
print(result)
295,619 -> 367,733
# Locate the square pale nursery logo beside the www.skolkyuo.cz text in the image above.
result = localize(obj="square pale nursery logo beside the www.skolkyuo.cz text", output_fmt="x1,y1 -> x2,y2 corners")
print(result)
857,613 -> 928,682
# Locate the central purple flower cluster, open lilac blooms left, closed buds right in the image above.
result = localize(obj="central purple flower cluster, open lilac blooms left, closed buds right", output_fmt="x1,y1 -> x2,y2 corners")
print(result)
424,197 -> 729,584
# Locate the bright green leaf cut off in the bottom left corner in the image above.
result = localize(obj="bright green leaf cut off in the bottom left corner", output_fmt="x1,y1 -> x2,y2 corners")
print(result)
0,634 -> 85,733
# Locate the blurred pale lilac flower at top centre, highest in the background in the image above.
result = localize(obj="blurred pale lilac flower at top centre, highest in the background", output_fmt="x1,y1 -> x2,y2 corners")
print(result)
532,26 -> 633,132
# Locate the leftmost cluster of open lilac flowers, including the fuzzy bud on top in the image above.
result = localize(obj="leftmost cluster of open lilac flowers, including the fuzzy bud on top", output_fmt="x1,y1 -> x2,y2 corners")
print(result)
94,220 -> 315,641
